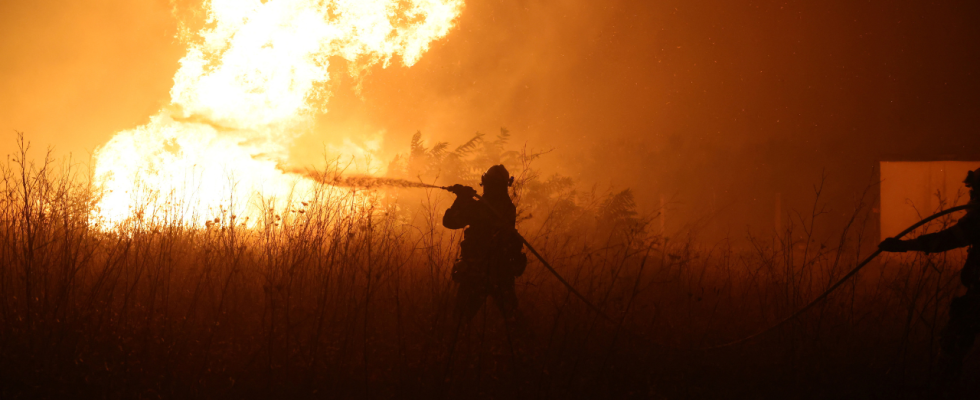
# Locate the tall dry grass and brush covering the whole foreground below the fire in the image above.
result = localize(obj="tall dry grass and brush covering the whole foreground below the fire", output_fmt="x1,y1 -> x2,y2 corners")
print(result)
0,134 -> 980,399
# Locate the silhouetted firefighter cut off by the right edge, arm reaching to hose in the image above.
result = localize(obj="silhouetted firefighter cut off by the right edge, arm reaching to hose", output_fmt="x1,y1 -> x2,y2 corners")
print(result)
878,169 -> 980,389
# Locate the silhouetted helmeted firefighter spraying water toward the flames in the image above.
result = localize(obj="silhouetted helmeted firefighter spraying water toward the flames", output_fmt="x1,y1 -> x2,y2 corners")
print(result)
442,165 -> 527,322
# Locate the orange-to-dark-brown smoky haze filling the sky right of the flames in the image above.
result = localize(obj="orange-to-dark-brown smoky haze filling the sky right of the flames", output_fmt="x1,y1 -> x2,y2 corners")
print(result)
301,0 -> 980,237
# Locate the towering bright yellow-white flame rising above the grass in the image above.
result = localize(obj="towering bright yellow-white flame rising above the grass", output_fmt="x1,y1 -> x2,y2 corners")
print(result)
95,0 -> 463,224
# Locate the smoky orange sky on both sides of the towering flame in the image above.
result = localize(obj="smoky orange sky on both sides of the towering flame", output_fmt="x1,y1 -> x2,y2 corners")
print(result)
0,0 -> 980,234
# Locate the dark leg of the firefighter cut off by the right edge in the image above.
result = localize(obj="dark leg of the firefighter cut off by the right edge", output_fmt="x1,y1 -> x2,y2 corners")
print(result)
938,291 -> 980,391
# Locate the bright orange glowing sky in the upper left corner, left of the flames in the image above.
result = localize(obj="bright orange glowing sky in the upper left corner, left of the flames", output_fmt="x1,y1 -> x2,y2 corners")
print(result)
0,0 -> 183,161
